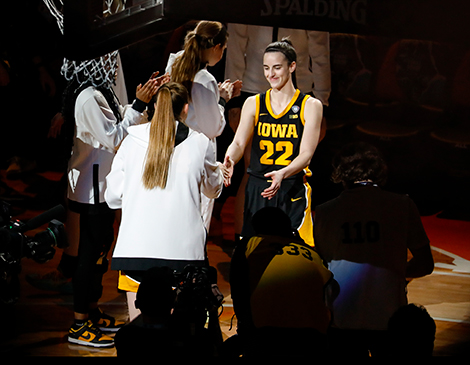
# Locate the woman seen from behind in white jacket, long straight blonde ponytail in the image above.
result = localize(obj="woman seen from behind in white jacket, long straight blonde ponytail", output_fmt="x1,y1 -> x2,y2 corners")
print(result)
105,82 -> 223,320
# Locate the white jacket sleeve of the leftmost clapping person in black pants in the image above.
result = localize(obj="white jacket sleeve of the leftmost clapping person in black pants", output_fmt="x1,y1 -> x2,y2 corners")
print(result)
75,91 -> 143,151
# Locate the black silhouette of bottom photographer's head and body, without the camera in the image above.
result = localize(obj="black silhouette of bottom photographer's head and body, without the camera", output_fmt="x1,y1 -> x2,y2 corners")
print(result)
114,267 -> 219,359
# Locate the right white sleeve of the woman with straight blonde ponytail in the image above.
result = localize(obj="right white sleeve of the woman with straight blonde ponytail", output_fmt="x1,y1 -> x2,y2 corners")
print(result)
201,140 -> 224,199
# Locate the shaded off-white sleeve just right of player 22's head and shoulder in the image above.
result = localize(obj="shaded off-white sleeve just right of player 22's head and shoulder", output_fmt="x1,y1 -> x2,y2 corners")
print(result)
307,31 -> 331,106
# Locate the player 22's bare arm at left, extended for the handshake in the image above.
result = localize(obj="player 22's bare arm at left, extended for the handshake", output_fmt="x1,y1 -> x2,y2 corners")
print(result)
224,96 -> 256,186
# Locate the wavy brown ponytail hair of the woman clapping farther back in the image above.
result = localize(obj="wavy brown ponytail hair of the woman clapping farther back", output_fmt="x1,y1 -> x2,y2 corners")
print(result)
171,20 -> 228,92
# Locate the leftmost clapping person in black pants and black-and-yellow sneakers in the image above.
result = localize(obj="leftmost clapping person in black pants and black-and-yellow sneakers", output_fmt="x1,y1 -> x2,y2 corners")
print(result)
64,52 -> 166,347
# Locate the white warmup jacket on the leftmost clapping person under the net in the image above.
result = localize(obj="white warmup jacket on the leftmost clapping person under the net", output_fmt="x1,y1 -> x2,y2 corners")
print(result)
67,86 -> 145,204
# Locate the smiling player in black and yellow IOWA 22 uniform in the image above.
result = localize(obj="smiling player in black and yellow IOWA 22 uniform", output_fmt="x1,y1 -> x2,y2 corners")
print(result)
224,39 -> 322,246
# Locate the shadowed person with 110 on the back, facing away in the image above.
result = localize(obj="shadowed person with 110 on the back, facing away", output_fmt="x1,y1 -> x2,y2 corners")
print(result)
315,142 -> 434,357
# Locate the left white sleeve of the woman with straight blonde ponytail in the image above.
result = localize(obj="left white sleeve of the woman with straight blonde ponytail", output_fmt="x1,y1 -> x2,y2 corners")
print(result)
104,147 -> 124,209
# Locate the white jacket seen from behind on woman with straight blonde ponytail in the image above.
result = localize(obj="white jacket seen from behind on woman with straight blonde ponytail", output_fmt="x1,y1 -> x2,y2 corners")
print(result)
105,123 -> 223,270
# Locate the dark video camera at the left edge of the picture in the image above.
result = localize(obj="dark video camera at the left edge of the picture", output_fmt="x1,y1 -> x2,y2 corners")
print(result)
0,201 -> 67,304
